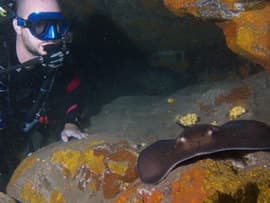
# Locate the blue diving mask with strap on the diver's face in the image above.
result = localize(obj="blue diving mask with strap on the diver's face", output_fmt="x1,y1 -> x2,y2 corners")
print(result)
16,12 -> 69,41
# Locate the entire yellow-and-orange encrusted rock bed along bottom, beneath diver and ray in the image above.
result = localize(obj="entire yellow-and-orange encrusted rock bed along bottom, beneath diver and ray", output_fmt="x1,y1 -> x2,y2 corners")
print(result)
7,138 -> 270,203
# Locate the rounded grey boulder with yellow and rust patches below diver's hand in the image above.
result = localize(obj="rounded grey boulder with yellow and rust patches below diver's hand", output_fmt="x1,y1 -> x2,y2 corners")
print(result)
7,139 -> 137,203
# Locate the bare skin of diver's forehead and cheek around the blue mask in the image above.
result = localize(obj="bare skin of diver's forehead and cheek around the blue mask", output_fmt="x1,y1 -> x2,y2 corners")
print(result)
14,0 -> 60,56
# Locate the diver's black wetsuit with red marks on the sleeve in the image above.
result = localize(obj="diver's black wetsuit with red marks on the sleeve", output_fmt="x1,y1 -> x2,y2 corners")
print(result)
0,23 -> 81,172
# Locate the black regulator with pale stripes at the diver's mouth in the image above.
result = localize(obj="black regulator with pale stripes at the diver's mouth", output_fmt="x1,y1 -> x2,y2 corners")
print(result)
42,50 -> 66,69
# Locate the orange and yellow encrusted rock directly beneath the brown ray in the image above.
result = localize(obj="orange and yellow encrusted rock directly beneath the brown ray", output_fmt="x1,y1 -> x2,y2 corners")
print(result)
113,152 -> 270,203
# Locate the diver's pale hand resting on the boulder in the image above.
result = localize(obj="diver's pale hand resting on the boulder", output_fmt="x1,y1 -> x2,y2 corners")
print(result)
61,123 -> 86,142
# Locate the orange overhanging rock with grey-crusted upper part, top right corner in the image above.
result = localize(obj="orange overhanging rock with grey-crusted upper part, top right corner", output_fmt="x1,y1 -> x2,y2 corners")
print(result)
163,0 -> 270,71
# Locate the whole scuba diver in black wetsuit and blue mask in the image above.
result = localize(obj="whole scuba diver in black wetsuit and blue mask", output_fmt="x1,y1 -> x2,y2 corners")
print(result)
0,0 -> 86,176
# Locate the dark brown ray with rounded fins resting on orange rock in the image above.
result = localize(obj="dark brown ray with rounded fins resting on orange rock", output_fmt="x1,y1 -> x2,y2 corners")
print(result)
137,120 -> 270,184
